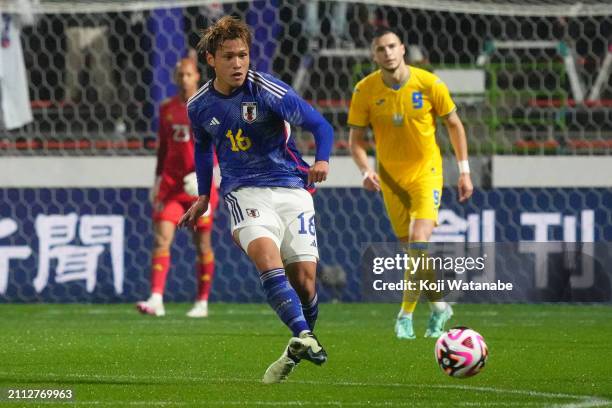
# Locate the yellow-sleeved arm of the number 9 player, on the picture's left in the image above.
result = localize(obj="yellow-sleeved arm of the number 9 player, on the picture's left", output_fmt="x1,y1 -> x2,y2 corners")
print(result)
348,83 -> 380,191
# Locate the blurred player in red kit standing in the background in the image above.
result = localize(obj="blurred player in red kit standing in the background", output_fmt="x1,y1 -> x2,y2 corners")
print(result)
137,58 -> 218,317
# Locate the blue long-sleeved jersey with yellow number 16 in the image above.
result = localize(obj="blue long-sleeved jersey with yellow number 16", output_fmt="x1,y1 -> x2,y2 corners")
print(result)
188,70 -> 333,195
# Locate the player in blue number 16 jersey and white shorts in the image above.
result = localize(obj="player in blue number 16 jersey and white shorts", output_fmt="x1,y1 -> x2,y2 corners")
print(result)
180,16 -> 333,384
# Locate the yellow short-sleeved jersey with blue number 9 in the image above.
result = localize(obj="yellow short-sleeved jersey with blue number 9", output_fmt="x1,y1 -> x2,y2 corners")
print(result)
348,66 -> 456,184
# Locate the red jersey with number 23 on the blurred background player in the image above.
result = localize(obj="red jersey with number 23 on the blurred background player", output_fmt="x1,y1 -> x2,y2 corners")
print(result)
155,95 -> 217,207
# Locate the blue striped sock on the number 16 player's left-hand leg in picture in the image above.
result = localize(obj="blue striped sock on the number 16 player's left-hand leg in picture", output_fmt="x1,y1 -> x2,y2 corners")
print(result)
259,268 -> 316,337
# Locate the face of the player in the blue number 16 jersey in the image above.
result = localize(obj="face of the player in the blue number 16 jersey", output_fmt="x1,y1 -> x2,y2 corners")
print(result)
206,38 -> 250,91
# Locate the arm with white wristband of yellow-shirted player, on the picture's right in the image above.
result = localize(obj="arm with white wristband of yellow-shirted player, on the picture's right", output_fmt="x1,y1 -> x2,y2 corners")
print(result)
431,77 -> 474,202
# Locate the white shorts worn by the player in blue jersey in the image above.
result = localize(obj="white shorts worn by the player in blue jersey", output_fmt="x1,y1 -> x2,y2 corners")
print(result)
224,187 -> 319,264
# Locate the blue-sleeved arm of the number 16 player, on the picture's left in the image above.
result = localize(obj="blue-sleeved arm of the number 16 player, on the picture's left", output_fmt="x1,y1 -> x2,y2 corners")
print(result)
178,111 -> 214,230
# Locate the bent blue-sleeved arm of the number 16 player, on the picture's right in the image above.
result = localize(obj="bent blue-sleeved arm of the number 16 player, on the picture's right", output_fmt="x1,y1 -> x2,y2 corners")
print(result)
272,88 -> 334,184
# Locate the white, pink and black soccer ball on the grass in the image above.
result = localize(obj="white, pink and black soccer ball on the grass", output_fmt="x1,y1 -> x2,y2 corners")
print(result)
435,327 -> 489,378
